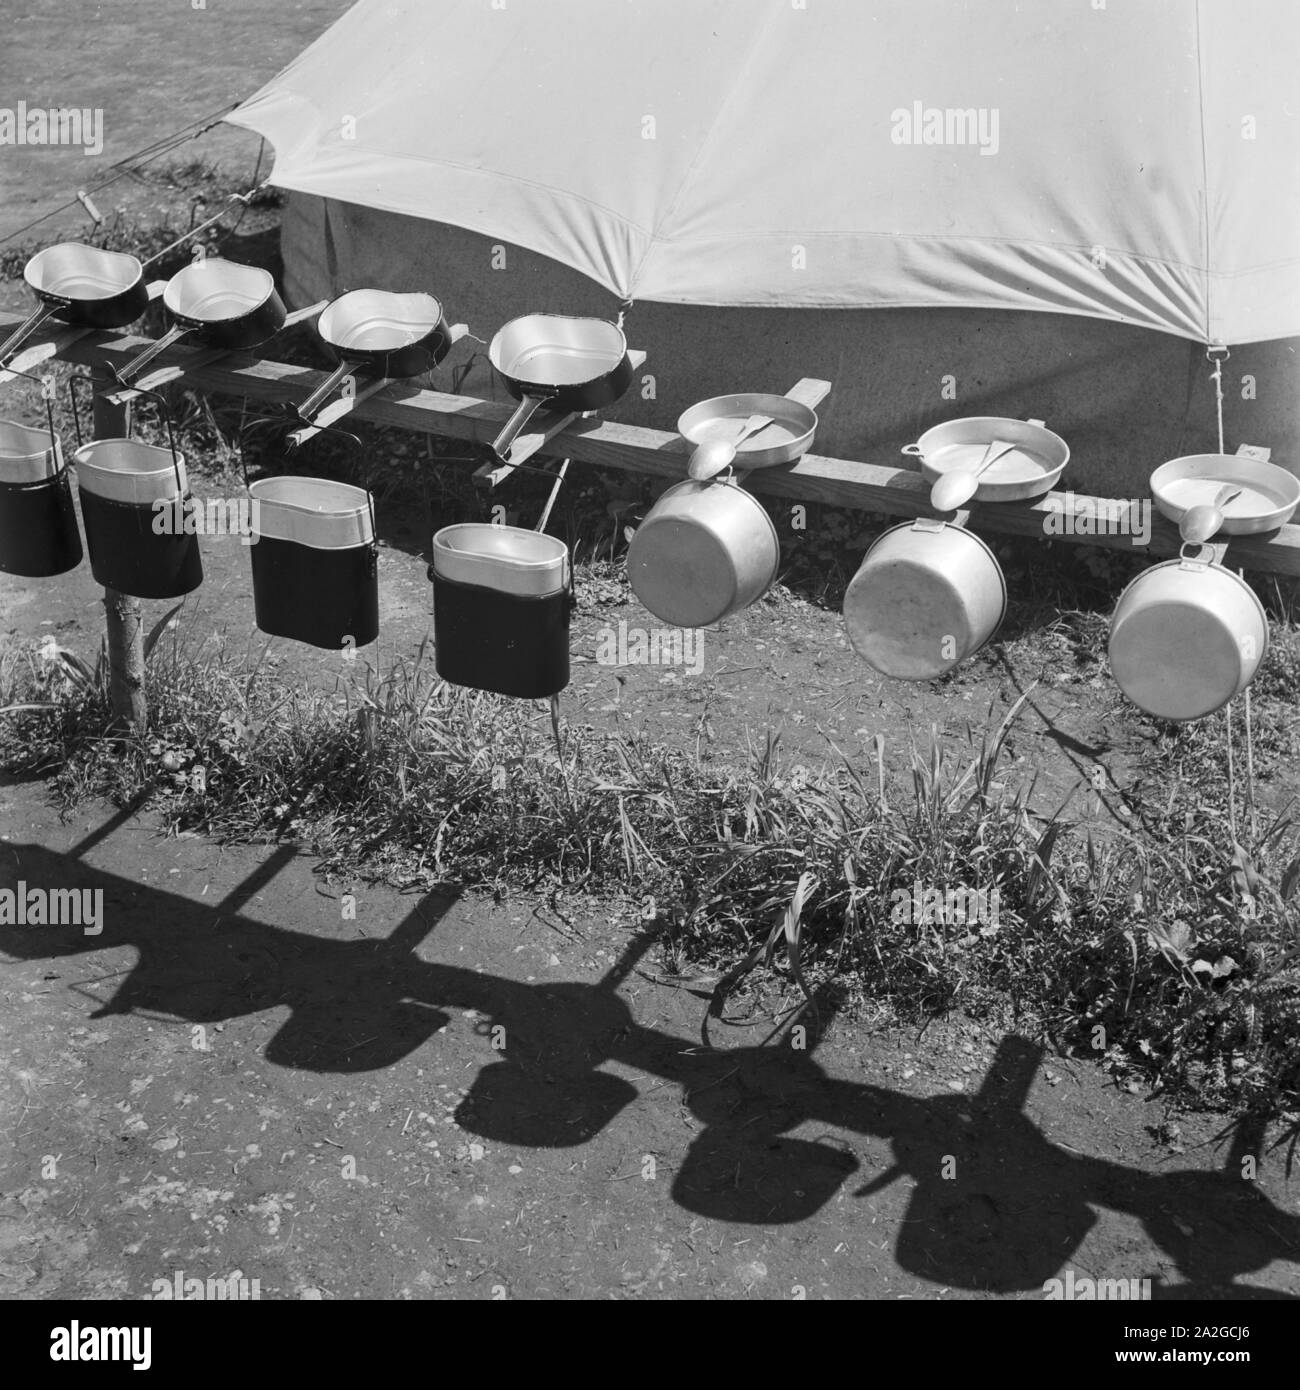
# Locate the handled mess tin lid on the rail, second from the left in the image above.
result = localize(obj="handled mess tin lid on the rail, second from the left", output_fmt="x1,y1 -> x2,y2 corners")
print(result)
114,256 -> 285,385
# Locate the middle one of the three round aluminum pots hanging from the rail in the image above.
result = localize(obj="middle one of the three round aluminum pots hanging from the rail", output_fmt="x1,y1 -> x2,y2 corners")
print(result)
844,517 -> 1007,681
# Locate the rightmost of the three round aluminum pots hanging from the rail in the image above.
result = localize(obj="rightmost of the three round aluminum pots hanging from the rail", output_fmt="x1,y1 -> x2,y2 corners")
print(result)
1108,546 -> 1268,721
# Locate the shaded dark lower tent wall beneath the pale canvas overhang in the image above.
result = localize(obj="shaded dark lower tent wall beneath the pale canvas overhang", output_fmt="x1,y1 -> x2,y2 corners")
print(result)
282,193 -> 1300,496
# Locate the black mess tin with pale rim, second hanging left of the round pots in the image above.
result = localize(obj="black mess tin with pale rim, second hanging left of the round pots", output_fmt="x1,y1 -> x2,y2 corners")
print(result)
247,477 -> 380,652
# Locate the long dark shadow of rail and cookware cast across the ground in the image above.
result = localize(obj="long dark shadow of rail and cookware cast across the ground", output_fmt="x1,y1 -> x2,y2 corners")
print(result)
0,823 -> 1300,1298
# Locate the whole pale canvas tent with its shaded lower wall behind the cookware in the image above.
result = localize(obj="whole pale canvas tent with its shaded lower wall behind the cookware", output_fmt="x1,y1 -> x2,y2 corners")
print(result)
231,0 -> 1300,491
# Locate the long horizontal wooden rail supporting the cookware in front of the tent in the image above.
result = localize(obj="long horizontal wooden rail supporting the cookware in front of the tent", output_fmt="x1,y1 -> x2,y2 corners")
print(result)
0,314 -> 1300,575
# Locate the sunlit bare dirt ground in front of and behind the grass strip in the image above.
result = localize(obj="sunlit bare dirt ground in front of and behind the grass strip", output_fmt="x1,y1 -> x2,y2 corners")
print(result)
0,520 -> 1300,1300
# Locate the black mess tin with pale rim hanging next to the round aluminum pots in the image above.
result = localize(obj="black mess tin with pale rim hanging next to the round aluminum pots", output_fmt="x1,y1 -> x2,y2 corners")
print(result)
428,523 -> 573,699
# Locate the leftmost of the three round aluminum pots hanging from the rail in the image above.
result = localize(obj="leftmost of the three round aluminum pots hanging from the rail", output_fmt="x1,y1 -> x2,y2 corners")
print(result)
627,478 -> 781,627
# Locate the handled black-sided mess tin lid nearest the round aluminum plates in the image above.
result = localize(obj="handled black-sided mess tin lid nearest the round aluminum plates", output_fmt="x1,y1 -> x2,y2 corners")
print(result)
488,314 -> 633,463
